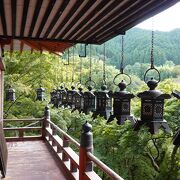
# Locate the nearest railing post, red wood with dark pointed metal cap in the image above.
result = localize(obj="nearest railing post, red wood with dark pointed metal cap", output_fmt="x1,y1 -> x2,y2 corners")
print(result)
79,121 -> 93,180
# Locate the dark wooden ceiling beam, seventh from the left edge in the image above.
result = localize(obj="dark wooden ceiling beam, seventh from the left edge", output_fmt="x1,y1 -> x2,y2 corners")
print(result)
51,0 -> 84,38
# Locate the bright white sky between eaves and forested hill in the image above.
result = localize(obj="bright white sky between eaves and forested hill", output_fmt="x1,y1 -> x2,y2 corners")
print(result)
136,3 -> 180,31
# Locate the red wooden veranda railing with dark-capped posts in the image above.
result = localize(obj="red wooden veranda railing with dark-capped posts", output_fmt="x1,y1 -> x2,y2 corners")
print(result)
4,107 -> 122,180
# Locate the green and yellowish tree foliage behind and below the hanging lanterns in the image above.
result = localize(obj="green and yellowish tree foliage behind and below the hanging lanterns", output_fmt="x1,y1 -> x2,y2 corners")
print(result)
4,46 -> 180,180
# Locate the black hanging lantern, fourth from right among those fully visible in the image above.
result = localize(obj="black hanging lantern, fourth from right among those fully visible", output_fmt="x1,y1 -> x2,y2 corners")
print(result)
83,86 -> 96,114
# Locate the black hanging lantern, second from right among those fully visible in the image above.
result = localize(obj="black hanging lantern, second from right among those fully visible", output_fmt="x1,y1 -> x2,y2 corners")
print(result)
107,76 -> 136,125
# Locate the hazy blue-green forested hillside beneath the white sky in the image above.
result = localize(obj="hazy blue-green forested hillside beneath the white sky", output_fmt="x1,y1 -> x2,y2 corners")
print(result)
88,28 -> 180,67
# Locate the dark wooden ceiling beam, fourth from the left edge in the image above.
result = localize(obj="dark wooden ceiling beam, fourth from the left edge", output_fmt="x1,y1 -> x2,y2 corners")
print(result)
28,0 -> 43,37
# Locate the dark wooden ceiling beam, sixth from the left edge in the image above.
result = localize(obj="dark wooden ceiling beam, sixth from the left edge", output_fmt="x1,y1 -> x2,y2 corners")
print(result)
43,0 -> 70,39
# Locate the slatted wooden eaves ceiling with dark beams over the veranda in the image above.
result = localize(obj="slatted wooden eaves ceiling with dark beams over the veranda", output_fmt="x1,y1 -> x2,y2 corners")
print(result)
0,0 -> 179,52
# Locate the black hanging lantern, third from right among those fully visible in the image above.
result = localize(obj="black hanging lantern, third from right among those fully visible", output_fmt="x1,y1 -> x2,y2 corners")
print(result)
93,85 -> 112,119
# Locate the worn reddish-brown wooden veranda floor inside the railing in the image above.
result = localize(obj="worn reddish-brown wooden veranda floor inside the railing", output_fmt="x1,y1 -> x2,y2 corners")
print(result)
5,140 -> 69,180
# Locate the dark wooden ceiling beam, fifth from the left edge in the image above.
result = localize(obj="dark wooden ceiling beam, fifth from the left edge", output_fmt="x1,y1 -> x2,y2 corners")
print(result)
36,0 -> 56,38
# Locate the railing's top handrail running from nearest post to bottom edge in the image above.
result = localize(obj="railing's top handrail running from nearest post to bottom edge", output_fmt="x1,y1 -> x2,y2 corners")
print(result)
87,152 -> 123,180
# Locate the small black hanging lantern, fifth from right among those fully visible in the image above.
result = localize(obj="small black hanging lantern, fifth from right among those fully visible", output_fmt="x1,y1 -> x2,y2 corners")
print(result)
73,87 -> 84,112
